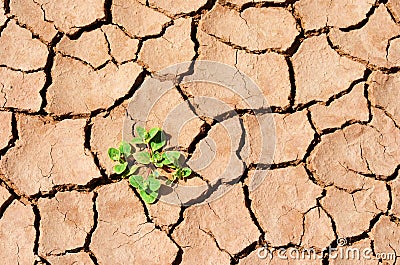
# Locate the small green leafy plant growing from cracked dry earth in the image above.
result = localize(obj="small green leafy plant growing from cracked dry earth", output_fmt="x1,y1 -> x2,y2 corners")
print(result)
108,127 -> 192,203
